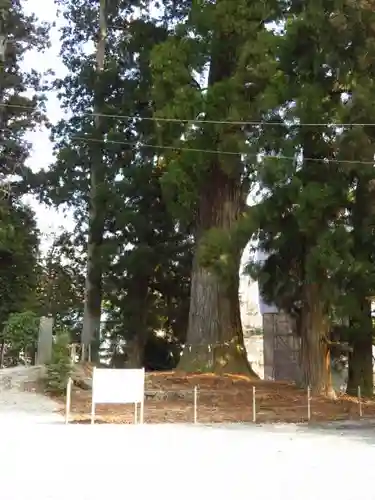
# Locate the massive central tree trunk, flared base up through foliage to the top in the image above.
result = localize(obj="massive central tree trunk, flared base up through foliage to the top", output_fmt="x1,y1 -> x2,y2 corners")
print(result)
178,0 -> 258,378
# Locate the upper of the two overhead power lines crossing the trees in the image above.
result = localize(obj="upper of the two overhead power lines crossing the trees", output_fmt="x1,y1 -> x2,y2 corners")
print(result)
0,103 -> 375,128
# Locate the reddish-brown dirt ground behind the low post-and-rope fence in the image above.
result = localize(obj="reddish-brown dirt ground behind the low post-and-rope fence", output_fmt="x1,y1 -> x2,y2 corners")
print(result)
54,368 -> 375,424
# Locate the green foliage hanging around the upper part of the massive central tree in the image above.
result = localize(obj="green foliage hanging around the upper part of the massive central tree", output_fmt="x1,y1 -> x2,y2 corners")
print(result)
151,0 -> 278,223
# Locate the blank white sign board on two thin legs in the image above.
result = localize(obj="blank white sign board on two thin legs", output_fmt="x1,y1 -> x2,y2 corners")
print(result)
91,368 -> 145,421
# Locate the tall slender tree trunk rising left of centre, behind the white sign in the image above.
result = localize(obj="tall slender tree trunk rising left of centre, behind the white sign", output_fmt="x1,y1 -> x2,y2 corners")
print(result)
82,0 -> 107,363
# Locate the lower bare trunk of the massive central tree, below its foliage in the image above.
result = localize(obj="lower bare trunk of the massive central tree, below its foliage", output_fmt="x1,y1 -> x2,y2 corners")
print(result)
178,169 -> 258,378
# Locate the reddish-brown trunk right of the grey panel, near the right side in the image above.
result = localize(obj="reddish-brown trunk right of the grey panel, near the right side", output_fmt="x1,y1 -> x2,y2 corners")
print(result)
300,283 -> 334,396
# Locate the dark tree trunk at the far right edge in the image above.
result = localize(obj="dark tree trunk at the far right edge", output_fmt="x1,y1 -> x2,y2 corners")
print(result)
347,299 -> 374,397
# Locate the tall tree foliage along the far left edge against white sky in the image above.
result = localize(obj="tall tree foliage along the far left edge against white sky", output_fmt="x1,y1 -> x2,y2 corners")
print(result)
0,0 -> 48,332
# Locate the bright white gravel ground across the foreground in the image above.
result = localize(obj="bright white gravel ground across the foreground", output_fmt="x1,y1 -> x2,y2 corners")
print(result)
0,412 -> 375,500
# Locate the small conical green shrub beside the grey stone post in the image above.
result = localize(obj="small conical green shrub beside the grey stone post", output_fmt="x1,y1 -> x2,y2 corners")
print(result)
45,330 -> 72,395
